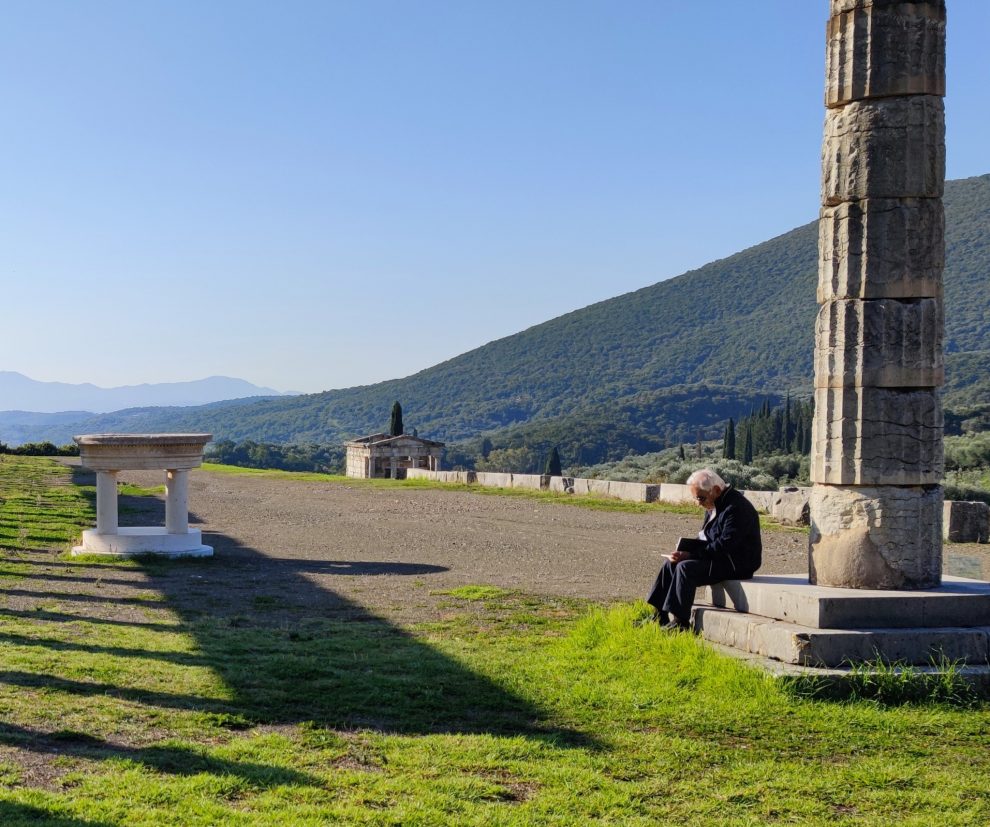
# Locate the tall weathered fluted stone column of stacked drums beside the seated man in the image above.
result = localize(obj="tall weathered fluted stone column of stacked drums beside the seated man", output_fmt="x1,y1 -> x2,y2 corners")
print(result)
809,0 -> 945,589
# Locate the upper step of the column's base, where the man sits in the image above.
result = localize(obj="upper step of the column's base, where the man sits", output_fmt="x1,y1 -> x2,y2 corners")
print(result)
696,574 -> 990,630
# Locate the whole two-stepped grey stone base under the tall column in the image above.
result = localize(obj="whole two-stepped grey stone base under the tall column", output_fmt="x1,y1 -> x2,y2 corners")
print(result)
693,575 -> 990,667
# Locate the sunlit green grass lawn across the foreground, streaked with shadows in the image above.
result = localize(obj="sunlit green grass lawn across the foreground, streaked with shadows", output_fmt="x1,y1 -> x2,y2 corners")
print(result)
0,456 -> 990,827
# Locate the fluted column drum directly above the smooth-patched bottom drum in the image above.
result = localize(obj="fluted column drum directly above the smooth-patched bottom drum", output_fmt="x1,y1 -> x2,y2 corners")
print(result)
811,387 -> 943,486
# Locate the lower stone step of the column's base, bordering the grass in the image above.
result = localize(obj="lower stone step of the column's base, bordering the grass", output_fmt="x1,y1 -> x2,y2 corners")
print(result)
692,606 -> 990,667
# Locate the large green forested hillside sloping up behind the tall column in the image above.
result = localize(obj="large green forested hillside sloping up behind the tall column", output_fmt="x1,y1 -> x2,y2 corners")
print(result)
31,175 -> 990,442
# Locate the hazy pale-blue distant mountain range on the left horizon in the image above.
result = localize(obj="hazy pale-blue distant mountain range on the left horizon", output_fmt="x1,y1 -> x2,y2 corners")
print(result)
0,371 -> 282,413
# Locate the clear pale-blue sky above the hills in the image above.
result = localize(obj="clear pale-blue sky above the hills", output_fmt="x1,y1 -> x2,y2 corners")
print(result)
0,0 -> 990,394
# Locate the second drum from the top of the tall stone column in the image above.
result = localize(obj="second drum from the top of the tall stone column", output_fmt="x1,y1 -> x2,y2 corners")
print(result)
822,95 -> 945,206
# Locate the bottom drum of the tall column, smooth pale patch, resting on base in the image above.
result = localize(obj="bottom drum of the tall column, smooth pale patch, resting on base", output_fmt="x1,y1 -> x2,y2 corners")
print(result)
808,485 -> 942,589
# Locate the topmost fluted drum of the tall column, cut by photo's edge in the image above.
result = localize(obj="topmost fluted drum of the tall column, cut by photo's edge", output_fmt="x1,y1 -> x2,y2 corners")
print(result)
825,2 -> 945,107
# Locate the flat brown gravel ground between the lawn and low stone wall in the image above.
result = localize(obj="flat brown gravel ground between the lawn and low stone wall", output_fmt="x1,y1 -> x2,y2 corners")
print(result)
60,469 -> 984,622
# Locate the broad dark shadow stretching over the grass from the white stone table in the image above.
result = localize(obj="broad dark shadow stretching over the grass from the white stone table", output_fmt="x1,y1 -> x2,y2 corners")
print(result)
31,469 -> 597,748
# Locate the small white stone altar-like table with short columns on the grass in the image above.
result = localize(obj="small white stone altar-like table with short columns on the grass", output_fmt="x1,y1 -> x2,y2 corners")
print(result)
72,434 -> 213,557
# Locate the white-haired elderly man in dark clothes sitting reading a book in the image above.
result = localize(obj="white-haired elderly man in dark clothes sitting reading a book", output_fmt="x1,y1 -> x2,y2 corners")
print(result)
646,468 -> 763,630
